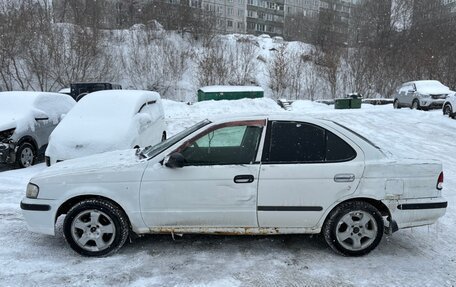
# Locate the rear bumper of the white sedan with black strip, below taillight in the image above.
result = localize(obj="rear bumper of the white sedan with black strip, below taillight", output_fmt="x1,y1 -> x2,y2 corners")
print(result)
382,197 -> 448,229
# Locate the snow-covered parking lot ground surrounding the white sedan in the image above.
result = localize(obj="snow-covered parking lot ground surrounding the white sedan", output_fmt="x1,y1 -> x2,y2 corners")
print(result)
0,99 -> 456,287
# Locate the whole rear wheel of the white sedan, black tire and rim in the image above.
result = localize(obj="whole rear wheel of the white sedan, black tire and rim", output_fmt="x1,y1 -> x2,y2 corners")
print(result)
322,201 -> 384,256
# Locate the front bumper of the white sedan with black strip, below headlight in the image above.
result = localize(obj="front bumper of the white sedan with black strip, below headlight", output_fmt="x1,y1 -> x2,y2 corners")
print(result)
21,197 -> 58,235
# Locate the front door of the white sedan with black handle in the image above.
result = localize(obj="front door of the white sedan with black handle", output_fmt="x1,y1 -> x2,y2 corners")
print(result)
140,121 -> 265,228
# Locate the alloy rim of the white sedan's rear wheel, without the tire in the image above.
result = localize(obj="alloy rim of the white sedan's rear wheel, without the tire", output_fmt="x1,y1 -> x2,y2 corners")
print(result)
336,210 -> 378,251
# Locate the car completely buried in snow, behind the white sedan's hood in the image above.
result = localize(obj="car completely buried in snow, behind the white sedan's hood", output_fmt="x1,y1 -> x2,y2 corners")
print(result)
45,90 -> 166,166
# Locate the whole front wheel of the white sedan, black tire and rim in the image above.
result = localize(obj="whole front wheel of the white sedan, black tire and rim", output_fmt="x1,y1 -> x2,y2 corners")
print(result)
63,199 -> 130,257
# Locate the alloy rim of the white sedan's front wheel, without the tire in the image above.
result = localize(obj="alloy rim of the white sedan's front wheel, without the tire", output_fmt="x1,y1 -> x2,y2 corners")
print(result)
71,209 -> 116,252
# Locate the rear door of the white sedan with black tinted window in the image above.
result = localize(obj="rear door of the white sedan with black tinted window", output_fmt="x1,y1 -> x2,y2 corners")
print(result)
257,121 -> 364,230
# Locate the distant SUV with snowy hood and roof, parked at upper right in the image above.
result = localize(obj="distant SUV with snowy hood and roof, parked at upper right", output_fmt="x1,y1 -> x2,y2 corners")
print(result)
393,80 -> 452,110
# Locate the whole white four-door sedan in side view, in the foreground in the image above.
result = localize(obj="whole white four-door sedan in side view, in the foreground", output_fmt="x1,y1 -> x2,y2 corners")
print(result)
21,113 -> 447,256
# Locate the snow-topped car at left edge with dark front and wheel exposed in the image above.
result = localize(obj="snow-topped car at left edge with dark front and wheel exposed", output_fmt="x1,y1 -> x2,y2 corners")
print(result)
0,92 -> 76,167
